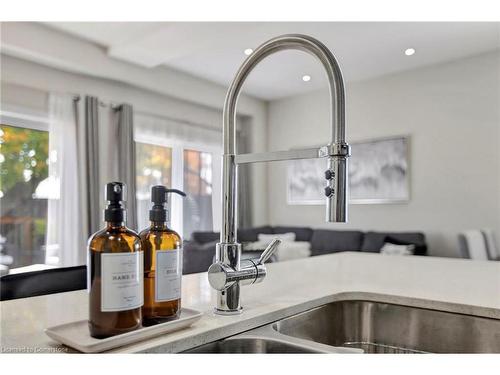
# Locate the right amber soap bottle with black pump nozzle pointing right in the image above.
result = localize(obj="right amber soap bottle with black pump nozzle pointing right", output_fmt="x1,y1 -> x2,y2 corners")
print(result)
139,185 -> 186,326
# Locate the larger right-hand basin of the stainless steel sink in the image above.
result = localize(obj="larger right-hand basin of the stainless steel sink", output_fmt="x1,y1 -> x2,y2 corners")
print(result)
273,301 -> 500,353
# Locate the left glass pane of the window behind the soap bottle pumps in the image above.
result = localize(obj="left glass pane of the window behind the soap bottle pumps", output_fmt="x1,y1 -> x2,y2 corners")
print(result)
136,142 -> 172,230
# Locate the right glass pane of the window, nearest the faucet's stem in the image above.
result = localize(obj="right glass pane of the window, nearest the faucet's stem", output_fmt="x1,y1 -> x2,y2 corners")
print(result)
183,150 -> 213,238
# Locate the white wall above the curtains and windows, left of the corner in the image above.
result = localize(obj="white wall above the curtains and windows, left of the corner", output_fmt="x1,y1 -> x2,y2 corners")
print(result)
0,22 -> 268,228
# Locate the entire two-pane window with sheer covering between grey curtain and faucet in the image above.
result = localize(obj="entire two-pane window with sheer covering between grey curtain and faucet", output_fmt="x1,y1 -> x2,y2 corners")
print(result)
134,114 -> 222,240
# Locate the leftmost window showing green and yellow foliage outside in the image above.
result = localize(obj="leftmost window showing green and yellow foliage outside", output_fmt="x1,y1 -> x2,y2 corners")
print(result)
0,124 -> 49,268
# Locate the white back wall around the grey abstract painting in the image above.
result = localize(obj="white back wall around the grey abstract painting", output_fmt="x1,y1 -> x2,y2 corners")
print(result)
268,53 -> 500,256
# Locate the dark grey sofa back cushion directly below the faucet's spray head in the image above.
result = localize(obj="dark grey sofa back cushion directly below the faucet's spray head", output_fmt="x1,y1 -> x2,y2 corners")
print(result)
311,229 -> 363,256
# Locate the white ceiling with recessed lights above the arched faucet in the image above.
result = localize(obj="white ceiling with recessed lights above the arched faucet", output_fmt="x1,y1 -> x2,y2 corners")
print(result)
48,22 -> 500,100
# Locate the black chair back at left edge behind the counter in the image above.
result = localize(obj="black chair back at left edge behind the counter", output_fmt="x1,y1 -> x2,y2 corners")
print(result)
0,266 -> 87,301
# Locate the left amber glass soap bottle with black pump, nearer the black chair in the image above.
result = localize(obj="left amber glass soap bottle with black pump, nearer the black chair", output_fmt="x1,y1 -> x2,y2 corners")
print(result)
87,182 -> 144,338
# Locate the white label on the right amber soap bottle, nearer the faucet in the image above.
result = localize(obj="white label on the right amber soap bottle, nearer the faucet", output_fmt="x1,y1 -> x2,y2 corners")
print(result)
155,249 -> 182,302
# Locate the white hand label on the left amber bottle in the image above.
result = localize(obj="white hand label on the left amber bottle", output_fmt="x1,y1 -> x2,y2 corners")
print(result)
101,251 -> 144,312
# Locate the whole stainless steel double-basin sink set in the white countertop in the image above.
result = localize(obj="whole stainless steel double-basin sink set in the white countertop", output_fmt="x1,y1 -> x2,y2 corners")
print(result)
187,300 -> 500,353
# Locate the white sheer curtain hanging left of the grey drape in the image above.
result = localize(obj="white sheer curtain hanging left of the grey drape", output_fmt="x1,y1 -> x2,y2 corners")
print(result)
45,94 -> 81,267
